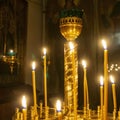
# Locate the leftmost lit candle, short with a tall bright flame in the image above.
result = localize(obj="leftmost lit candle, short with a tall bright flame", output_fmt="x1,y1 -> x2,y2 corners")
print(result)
22,96 -> 27,120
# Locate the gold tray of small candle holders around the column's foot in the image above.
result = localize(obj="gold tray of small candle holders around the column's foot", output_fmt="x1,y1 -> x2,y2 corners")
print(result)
13,103 -> 120,120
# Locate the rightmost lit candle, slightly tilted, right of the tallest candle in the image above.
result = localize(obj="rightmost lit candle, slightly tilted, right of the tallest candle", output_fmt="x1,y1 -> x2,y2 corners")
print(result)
110,75 -> 117,111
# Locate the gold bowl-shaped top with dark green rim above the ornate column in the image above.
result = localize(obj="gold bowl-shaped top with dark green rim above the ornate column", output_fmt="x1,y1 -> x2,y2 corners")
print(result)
60,0 -> 83,41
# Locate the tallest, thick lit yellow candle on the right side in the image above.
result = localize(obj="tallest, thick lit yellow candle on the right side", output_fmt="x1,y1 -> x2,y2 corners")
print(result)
102,40 -> 108,120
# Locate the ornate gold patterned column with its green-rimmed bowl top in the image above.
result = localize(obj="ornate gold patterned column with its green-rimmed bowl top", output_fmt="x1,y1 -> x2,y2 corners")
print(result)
60,5 -> 83,120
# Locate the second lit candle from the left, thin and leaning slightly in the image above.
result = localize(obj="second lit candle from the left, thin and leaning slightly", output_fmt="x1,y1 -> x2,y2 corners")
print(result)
32,62 -> 37,113
